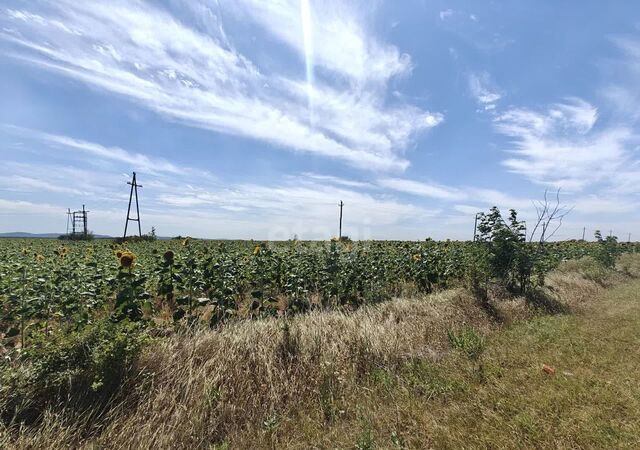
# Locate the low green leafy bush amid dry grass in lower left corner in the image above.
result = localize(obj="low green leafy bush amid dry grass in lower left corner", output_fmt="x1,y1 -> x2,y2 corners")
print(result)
0,320 -> 147,423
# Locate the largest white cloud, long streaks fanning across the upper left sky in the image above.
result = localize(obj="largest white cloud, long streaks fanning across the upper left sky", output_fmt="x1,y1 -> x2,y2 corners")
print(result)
0,0 -> 442,171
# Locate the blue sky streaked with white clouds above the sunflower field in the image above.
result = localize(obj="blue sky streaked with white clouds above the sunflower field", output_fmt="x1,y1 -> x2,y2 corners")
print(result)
0,0 -> 640,241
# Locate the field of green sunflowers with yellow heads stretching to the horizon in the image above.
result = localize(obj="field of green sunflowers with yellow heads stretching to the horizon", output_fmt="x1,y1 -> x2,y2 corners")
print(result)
0,238 -> 640,348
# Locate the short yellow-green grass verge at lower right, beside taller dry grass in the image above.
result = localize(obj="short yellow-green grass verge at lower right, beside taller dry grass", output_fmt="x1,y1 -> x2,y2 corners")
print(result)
276,281 -> 640,448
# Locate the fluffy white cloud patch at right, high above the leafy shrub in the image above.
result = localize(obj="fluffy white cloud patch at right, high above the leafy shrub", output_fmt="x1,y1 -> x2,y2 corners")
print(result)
494,98 -> 636,190
